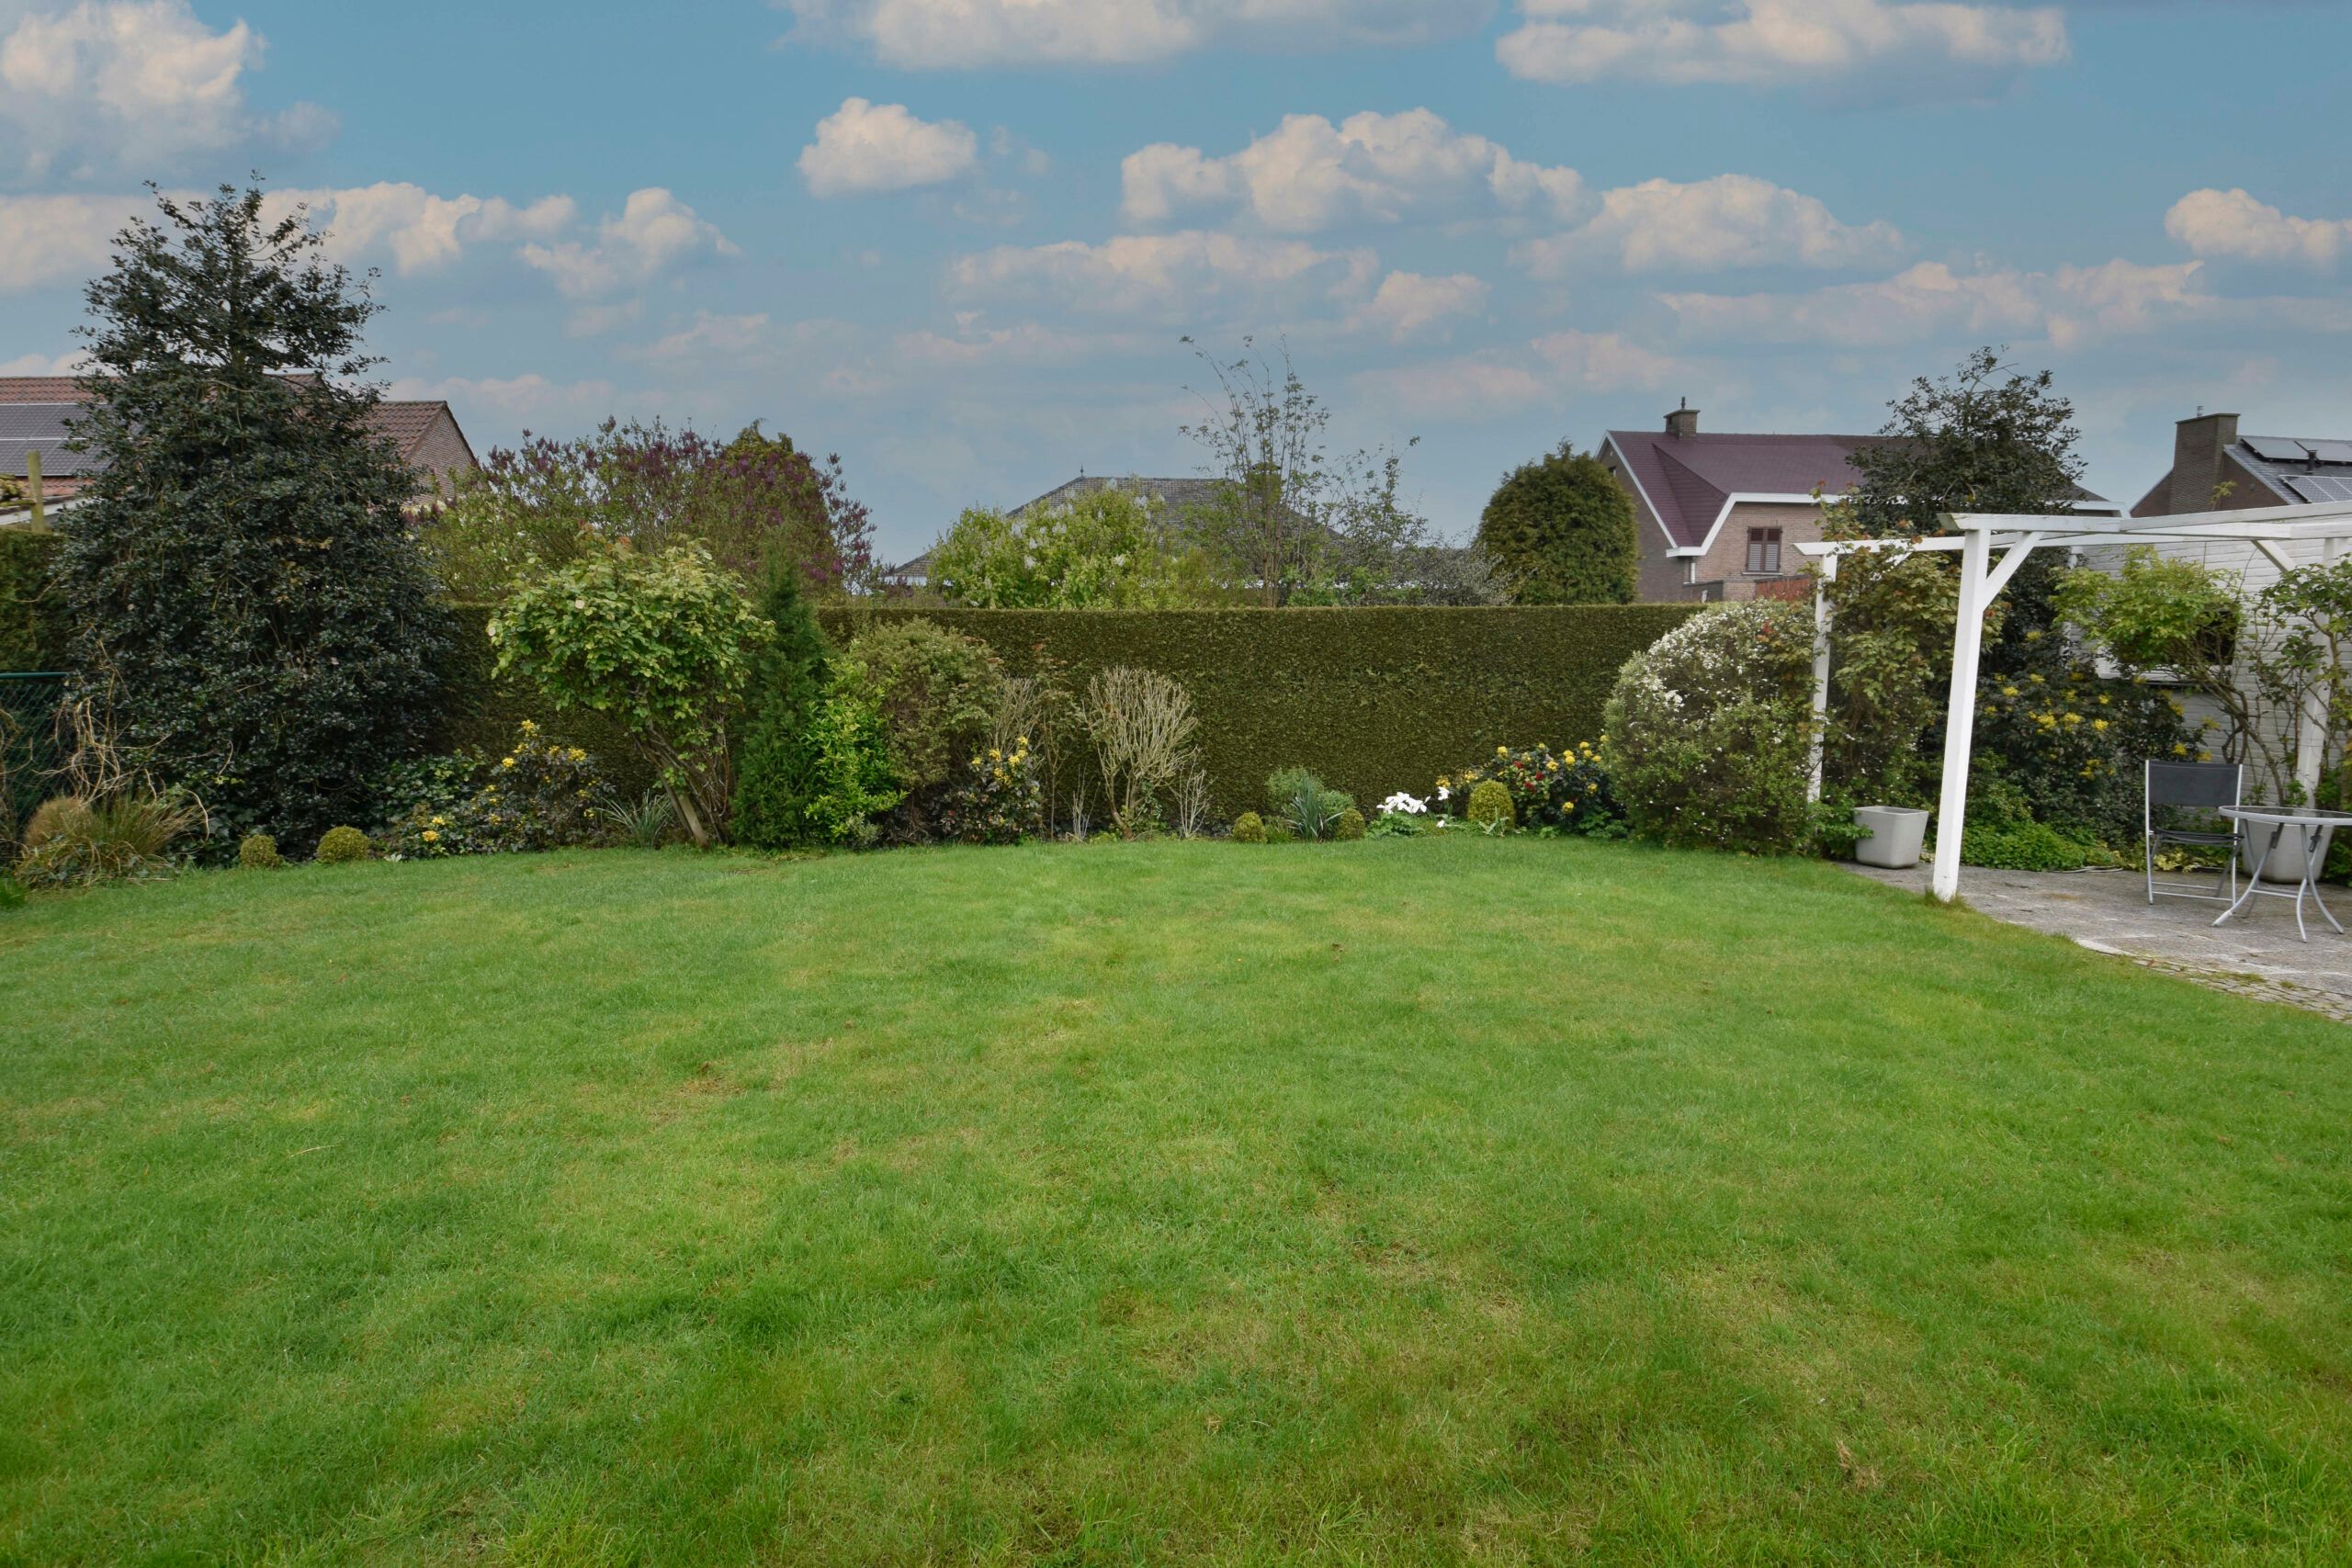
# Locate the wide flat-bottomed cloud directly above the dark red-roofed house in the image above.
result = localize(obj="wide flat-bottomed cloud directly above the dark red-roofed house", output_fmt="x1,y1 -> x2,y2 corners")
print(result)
1512,174 -> 1903,277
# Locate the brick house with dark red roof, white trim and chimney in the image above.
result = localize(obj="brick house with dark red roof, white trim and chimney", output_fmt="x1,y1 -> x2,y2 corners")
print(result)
1600,404 -> 2117,602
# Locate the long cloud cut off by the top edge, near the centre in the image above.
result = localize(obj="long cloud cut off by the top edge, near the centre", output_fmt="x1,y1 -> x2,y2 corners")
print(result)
776,0 -> 1494,68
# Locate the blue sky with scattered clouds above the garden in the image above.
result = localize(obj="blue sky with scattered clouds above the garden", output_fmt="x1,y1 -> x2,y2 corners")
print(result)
0,0 -> 2352,558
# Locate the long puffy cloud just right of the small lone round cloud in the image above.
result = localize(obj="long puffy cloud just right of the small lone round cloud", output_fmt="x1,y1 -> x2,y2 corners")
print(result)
1120,108 -> 1583,232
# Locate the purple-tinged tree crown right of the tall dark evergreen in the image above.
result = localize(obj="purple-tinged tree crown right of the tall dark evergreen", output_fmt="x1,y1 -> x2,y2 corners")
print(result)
424,419 -> 875,600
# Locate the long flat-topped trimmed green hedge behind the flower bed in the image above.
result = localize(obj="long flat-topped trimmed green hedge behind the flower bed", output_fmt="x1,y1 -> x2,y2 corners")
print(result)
819,604 -> 1698,818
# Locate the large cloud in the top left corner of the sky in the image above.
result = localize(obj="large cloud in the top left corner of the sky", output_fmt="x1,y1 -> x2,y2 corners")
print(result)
0,0 -> 334,179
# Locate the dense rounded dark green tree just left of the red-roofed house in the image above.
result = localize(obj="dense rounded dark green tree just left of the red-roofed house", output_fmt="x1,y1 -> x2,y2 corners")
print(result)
1477,442 -> 1642,604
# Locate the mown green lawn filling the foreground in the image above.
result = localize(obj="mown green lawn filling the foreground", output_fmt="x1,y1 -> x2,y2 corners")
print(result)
14,840 -> 2352,1563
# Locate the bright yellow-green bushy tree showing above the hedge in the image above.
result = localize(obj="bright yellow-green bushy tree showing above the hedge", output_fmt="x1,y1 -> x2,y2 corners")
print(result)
932,484 -> 1218,609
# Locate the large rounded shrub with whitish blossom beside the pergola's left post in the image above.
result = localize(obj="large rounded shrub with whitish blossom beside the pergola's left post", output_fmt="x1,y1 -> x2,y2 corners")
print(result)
1601,600 -> 1814,856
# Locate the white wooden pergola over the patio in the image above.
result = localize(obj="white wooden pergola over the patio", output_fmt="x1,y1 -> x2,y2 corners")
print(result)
1797,501 -> 2352,903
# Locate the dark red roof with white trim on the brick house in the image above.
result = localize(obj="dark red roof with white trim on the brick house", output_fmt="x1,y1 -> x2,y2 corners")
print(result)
1604,416 -> 2112,552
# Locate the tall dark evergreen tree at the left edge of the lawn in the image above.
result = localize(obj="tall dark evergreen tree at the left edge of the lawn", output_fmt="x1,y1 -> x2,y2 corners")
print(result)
59,186 -> 449,860
